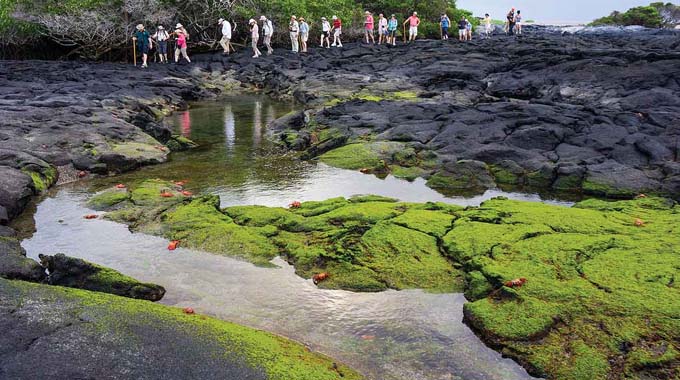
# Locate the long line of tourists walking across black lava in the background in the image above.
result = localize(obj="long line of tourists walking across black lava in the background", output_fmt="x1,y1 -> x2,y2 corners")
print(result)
132,8 -> 522,68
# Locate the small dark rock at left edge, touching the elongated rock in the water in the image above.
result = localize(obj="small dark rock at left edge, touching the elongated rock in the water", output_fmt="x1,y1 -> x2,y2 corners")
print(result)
0,237 -> 46,282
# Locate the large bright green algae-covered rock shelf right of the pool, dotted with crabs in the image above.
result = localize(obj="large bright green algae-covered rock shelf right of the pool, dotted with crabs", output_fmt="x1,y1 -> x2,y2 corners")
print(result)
89,182 -> 680,379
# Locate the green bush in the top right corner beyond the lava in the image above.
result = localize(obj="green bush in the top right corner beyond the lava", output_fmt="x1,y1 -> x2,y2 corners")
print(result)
591,2 -> 680,28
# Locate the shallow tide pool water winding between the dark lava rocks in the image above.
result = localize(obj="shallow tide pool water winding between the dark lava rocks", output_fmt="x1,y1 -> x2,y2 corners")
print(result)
22,97 -> 561,379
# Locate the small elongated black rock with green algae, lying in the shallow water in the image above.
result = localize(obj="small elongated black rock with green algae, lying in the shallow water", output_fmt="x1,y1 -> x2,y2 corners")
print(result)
40,253 -> 165,301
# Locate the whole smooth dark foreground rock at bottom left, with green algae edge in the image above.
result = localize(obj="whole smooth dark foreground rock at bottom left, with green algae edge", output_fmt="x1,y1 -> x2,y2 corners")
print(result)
0,279 -> 362,380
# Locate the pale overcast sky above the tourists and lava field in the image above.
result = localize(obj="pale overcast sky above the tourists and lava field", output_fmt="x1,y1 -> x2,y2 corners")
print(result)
456,0 -> 678,23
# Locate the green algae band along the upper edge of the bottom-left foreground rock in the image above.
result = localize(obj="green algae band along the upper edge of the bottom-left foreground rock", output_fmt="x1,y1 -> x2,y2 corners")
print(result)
0,279 -> 362,380
